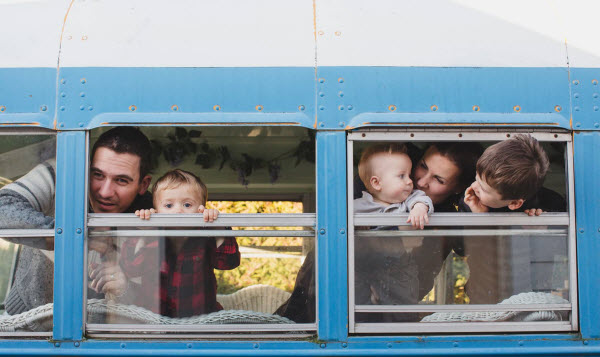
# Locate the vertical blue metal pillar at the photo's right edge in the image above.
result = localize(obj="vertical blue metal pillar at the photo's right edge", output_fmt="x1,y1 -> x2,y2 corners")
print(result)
573,131 -> 600,338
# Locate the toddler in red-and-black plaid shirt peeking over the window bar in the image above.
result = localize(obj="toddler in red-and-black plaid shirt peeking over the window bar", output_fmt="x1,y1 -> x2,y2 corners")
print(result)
121,170 -> 240,317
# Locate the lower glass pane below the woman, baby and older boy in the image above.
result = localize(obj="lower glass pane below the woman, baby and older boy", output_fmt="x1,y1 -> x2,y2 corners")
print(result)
355,226 -> 570,322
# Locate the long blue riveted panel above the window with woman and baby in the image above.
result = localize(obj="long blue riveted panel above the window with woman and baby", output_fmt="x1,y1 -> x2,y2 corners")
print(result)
317,67 -> 570,128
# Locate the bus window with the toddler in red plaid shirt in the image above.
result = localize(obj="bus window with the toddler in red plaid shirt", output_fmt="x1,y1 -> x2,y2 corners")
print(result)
87,127 -> 316,336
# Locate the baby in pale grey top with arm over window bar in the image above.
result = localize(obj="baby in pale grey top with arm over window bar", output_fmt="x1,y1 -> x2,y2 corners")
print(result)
354,143 -> 433,312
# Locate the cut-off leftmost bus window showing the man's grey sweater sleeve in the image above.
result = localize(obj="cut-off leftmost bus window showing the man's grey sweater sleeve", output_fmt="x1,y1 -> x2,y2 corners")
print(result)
0,129 -> 56,336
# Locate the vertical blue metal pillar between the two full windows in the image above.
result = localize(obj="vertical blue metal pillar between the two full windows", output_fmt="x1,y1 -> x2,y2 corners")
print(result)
316,131 -> 348,341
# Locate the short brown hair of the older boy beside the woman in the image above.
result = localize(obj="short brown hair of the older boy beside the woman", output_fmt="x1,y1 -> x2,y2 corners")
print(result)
477,134 -> 550,200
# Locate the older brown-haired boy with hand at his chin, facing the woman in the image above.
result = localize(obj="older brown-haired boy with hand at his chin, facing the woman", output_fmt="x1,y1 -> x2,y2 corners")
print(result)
461,135 -> 552,211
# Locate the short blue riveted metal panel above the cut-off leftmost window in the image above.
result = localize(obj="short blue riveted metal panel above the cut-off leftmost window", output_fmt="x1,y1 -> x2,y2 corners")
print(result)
0,68 -> 56,128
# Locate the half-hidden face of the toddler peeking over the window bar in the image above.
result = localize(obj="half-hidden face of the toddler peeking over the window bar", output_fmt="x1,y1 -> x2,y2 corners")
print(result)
154,184 -> 203,213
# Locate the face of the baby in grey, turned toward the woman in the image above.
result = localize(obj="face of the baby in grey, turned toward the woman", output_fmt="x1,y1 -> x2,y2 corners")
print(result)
370,153 -> 413,204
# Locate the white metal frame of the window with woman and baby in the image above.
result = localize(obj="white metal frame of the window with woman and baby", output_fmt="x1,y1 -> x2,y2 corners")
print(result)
347,128 -> 578,334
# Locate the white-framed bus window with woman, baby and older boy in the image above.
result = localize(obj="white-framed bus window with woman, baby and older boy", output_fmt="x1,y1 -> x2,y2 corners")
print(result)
348,129 -> 577,333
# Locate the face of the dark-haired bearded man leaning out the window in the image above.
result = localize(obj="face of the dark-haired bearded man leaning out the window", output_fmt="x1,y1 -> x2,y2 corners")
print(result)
90,147 -> 150,213
